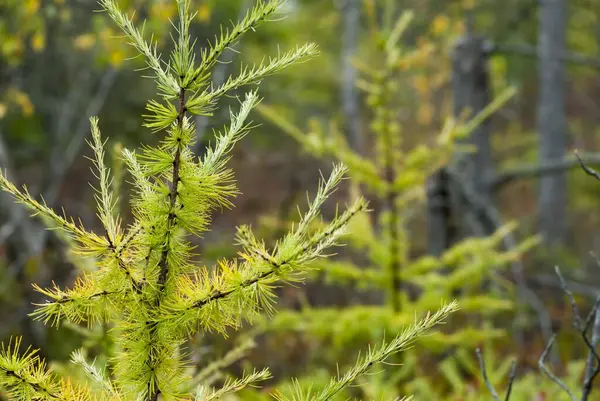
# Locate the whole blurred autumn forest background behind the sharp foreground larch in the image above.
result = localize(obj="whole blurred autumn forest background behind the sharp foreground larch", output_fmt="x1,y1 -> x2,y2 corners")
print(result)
0,0 -> 600,400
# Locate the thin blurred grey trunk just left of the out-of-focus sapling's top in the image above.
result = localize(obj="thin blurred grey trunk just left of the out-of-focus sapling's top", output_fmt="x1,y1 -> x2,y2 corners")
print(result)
340,0 -> 364,153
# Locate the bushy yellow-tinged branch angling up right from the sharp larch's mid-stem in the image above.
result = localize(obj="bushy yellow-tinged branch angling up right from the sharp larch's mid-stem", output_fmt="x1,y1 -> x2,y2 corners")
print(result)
164,193 -> 367,331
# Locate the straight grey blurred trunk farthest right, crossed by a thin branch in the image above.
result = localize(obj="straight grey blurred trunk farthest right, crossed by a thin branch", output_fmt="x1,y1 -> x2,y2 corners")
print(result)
537,0 -> 568,245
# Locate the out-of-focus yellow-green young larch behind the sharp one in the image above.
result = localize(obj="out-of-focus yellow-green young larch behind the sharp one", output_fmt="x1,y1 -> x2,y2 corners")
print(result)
253,6 -> 537,396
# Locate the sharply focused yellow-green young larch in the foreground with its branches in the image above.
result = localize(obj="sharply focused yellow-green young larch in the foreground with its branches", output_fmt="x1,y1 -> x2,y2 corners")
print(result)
0,0 -> 457,401
